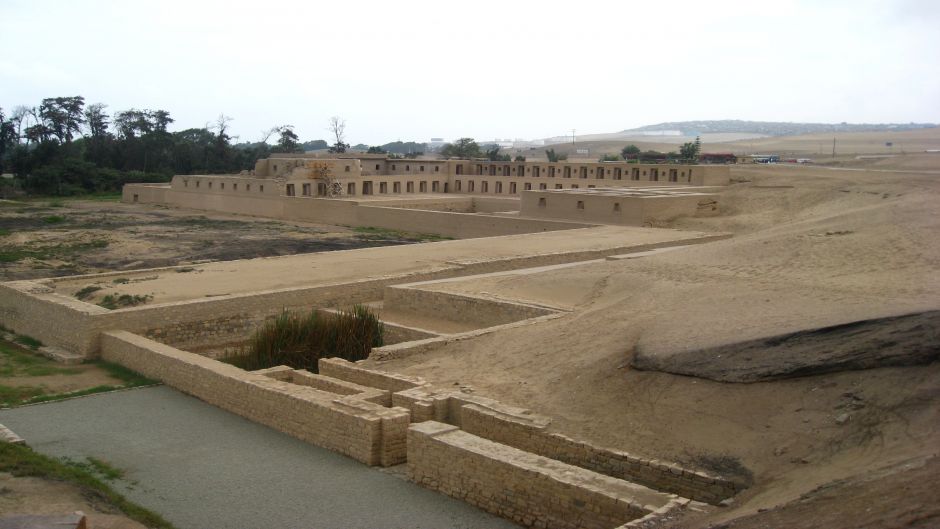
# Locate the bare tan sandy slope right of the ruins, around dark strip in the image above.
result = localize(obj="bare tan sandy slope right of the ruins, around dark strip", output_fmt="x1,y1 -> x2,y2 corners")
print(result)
362,159 -> 940,527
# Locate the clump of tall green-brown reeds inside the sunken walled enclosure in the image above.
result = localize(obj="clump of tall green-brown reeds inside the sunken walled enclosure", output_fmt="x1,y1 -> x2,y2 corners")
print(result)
226,305 -> 384,373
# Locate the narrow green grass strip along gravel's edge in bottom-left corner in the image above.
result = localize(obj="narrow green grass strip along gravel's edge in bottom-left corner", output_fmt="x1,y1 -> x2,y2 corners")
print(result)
0,443 -> 174,529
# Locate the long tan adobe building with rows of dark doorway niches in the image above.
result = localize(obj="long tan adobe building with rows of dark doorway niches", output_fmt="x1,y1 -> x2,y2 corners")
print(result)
124,154 -> 729,228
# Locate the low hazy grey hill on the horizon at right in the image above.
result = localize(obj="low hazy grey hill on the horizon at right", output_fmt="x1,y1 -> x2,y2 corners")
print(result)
620,119 -> 937,136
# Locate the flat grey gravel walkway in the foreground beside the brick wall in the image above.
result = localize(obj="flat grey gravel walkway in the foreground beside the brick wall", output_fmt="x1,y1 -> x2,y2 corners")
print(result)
0,386 -> 516,529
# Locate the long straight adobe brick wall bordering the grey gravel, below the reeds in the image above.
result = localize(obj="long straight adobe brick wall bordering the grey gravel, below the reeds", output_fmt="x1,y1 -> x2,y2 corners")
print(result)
101,331 -> 409,466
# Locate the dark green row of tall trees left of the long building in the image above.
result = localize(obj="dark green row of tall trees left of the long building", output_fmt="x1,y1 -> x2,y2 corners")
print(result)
0,96 -> 348,195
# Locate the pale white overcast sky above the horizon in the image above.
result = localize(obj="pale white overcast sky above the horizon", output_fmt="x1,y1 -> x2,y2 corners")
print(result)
0,0 -> 940,144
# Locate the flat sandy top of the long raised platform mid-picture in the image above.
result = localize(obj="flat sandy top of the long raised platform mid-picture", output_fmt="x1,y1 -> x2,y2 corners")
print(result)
49,226 -> 705,303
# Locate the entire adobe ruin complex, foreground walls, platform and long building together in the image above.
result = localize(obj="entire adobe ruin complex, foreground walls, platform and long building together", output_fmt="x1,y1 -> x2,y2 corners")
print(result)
0,155 -> 745,529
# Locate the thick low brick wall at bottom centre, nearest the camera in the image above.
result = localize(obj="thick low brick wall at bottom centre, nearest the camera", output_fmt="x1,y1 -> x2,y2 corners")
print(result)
408,421 -> 681,529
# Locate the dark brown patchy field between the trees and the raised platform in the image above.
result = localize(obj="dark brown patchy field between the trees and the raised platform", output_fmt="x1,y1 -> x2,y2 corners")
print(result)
0,200 -> 430,281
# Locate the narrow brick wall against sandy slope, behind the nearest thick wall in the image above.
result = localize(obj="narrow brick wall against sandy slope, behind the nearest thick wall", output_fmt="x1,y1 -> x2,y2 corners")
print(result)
460,404 -> 742,504
